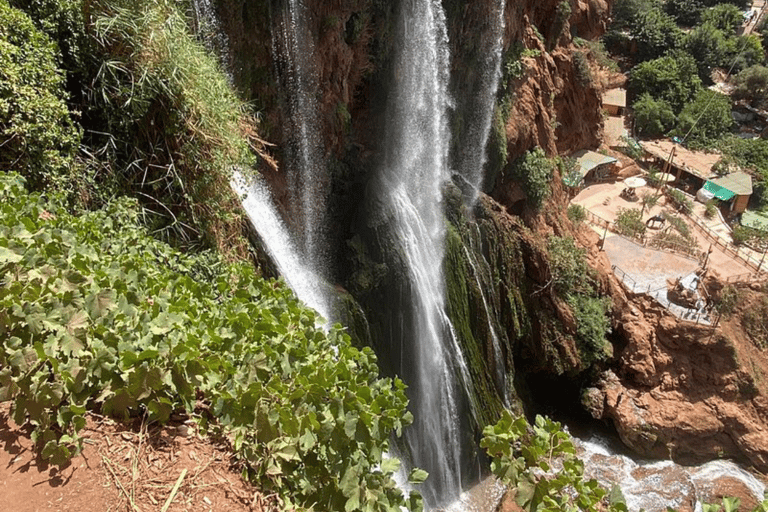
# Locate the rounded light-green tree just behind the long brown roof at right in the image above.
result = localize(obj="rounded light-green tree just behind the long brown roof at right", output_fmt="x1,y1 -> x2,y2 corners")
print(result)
675,89 -> 733,144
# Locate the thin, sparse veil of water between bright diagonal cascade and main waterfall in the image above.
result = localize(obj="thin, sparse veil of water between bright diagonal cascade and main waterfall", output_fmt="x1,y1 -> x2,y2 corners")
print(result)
272,0 -> 329,274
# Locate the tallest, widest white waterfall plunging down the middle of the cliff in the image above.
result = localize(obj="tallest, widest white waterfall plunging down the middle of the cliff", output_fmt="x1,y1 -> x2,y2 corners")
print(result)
378,0 -> 469,507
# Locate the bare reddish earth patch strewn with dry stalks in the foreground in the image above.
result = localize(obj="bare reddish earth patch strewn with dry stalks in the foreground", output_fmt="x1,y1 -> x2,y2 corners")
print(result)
0,404 -> 277,512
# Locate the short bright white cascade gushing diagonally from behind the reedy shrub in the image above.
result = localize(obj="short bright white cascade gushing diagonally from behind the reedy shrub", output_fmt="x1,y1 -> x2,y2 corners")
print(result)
231,173 -> 332,320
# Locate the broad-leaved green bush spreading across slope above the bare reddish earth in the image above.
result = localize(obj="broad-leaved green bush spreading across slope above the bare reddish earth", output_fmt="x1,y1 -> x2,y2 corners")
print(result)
0,174 -> 423,512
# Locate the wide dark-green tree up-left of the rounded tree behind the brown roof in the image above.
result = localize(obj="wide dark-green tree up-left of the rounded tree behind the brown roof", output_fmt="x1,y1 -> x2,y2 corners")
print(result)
629,51 -> 701,112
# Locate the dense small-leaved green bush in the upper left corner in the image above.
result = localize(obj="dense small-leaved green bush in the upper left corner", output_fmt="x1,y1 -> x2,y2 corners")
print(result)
0,0 -> 80,189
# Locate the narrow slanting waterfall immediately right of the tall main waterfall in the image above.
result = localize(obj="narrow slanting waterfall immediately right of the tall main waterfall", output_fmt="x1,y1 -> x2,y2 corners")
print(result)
458,0 -> 506,205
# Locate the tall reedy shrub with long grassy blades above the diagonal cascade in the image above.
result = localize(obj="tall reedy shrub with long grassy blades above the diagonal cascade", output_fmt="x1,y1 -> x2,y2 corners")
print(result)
89,0 -> 264,253
